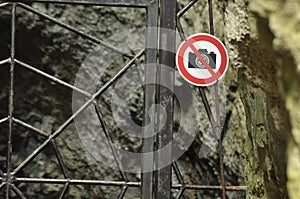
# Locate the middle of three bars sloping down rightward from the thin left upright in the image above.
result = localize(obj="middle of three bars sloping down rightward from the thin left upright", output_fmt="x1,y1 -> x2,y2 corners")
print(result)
15,59 -> 92,97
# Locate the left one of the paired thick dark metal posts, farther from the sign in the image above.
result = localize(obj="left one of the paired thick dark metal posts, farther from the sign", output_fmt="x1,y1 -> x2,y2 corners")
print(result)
141,0 -> 159,199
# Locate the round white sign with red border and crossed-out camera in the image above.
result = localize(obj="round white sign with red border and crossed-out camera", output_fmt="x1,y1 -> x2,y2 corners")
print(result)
176,33 -> 229,86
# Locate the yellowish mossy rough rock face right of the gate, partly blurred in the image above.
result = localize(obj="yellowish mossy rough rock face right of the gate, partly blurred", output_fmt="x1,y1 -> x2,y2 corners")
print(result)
225,0 -> 300,198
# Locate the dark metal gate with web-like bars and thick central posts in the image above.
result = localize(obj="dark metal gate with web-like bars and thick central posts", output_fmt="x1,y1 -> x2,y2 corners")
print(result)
0,0 -> 246,199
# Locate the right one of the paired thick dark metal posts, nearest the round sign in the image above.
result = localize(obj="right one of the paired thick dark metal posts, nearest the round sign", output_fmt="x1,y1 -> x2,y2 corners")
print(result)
155,0 -> 176,199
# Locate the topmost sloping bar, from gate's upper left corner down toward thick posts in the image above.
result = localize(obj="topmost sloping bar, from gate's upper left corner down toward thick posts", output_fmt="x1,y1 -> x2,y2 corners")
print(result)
18,3 -> 133,59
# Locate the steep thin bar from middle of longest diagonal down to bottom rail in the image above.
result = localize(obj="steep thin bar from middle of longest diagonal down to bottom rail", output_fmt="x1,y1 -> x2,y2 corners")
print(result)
94,102 -> 128,182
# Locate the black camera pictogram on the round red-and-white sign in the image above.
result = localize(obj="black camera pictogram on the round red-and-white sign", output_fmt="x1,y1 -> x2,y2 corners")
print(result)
188,49 -> 217,69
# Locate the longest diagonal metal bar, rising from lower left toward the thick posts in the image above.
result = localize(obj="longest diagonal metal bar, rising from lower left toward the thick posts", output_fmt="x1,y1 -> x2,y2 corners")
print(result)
13,50 -> 144,174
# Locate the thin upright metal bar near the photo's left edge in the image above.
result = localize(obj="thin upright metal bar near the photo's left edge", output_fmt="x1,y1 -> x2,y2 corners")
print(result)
6,3 -> 16,199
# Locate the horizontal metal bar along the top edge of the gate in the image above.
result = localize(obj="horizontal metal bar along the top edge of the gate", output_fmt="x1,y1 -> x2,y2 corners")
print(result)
8,0 -> 153,8
